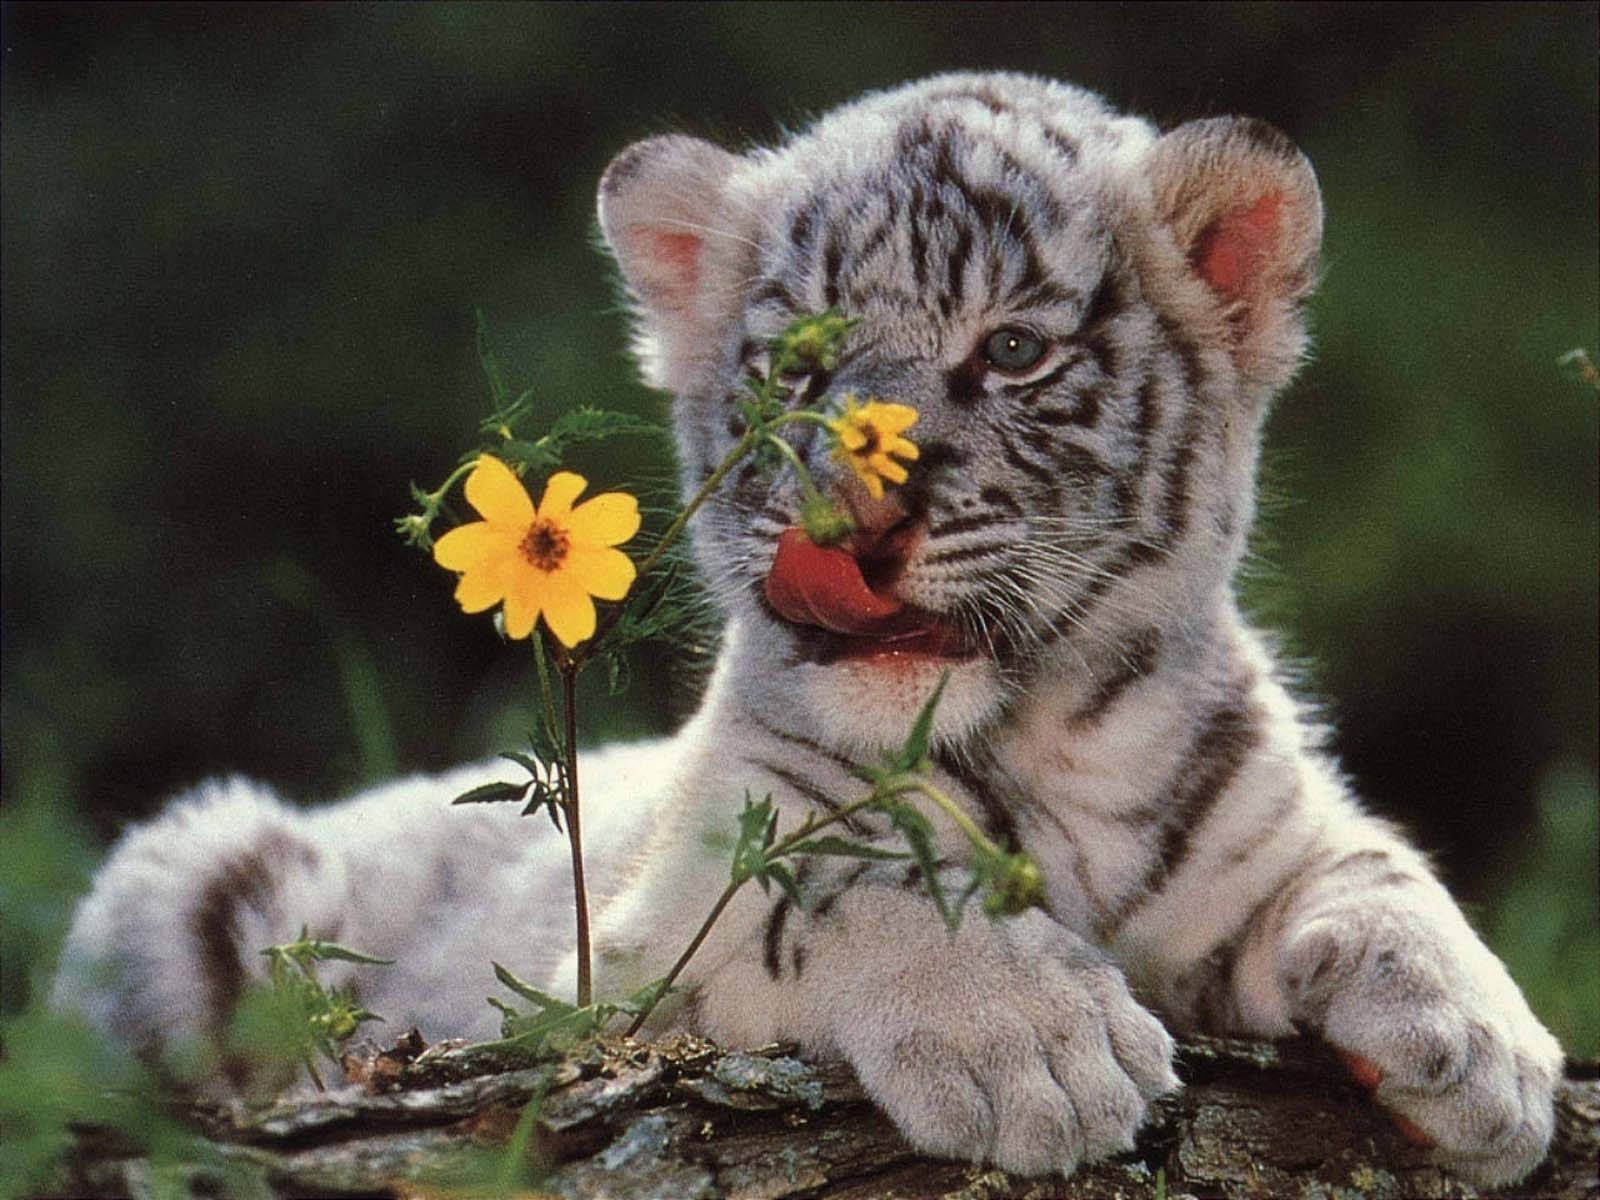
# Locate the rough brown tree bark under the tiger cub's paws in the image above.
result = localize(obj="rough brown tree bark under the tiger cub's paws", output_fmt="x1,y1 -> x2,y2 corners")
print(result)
62,1037 -> 1600,1200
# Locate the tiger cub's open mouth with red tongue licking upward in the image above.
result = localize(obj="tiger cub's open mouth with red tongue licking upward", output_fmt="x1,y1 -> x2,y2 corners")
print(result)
763,528 -> 978,664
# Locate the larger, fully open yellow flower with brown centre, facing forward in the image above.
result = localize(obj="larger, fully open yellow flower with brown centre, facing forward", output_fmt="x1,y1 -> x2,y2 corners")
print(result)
434,454 -> 638,648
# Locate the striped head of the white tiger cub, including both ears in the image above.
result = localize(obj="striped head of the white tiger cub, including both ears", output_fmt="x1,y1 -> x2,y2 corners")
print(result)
598,74 -> 1322,747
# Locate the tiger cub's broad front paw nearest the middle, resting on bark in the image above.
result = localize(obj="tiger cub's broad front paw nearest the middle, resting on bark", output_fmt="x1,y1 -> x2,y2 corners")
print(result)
846,928 -> 1178,1174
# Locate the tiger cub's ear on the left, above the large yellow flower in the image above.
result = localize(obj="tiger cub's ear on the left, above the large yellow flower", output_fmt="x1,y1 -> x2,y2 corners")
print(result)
597,136 -> 741,390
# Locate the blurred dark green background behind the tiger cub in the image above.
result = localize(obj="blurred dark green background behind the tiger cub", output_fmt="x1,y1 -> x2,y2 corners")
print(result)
0,3 -> 1600,1054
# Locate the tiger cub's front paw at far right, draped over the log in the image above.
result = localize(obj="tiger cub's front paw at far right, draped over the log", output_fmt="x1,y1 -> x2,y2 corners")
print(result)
1286,922 -> 1562,1187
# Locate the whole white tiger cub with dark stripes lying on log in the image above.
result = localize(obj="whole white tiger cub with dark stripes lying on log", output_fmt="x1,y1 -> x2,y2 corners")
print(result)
58,74 -> 1562,1184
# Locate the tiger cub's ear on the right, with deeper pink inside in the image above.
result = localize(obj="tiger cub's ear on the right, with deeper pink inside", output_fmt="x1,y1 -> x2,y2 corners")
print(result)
1150,117 -> 1322,387
